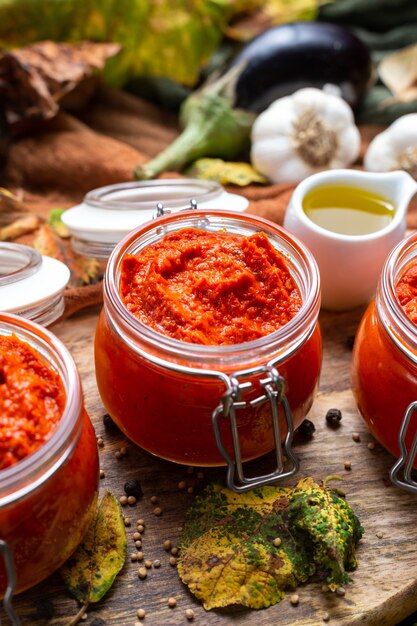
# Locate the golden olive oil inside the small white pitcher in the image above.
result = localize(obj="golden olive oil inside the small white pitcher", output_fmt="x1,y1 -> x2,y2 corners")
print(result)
303,186 -> 395,235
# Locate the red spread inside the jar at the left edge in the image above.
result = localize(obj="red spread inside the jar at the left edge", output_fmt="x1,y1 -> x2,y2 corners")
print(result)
0,335 -> 66,470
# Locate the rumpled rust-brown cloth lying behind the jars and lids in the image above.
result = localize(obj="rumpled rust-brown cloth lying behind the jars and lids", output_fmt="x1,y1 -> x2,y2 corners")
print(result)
2,86 -> 417,316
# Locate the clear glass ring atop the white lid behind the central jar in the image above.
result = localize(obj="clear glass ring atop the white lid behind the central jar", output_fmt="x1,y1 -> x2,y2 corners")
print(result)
84,178 -> 224,211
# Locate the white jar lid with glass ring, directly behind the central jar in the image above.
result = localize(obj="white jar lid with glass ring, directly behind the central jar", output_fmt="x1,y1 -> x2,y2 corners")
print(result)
62,178 -> 249,259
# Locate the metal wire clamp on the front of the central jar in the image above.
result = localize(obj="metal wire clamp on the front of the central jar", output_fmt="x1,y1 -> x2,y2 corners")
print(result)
212,365 -> 300,492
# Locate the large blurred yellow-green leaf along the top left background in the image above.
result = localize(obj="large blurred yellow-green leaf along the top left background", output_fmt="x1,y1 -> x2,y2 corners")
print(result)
0,0 -> 262,86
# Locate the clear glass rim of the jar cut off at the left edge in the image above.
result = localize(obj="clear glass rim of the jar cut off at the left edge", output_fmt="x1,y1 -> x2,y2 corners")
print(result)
0,312 -> 83,508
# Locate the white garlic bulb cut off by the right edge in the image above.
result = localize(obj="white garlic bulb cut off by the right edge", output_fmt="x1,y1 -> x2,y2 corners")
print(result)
363,113 -> 417,180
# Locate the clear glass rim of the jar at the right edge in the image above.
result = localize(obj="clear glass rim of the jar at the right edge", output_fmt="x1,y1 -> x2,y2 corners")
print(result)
376,233 -> 417,363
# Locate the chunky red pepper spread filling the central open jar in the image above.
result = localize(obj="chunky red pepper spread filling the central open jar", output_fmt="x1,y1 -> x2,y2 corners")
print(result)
120,228 -> 301,346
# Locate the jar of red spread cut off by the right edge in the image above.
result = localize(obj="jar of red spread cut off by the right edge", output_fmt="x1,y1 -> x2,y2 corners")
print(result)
352,229 -> 417,464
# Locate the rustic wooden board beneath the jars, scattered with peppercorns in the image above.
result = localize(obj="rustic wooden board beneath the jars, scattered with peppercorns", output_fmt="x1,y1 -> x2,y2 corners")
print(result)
4,310 -> 417,626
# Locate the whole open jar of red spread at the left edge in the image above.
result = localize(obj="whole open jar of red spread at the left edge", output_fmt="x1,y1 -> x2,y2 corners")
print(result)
0,313 -> 98,597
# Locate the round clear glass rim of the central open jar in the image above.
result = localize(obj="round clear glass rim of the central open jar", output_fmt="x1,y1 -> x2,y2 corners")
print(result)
103,209 -> 320,367
